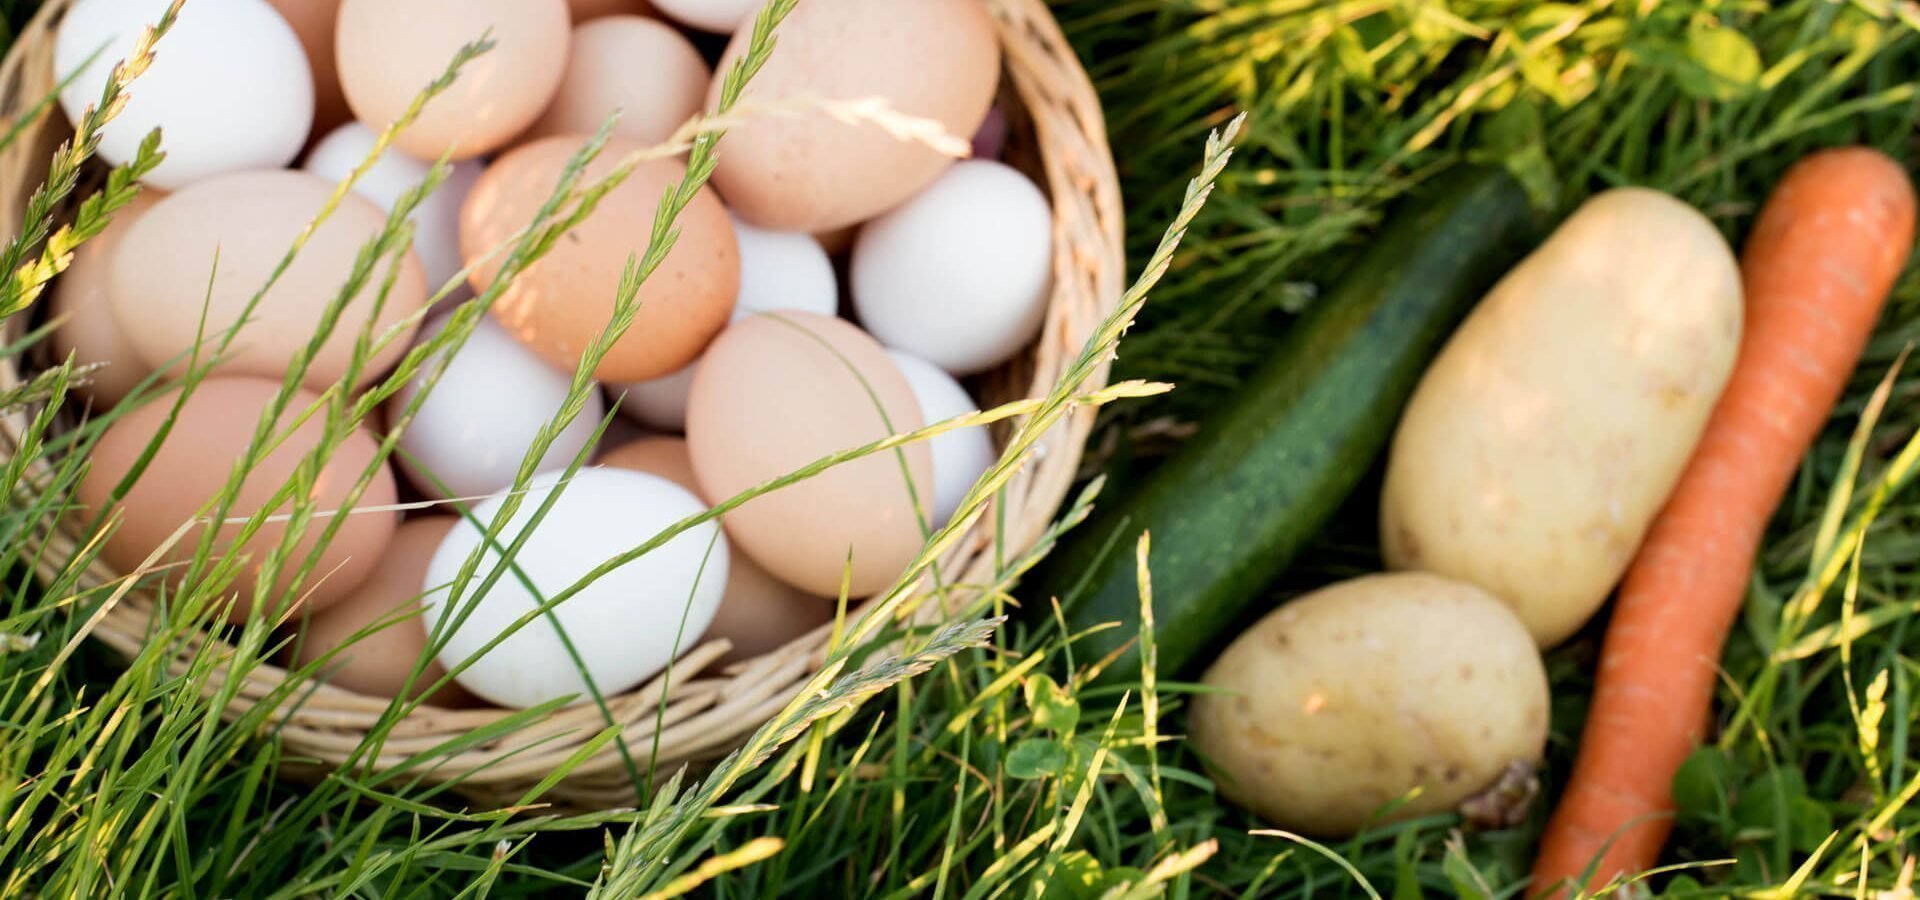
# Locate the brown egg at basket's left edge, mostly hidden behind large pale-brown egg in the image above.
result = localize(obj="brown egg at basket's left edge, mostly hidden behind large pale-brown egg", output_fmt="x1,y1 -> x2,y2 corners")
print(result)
50,190 -> 161,407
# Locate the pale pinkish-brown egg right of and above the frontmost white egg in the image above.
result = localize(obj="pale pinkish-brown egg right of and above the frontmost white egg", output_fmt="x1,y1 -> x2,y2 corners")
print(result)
687,313 -> 933,597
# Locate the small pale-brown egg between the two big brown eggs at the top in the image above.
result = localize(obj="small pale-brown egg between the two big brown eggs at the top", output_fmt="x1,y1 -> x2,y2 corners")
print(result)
530,15 -> 712,144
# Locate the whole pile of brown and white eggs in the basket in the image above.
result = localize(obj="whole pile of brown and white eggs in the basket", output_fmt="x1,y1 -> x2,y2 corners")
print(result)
54,0 -> 1052,706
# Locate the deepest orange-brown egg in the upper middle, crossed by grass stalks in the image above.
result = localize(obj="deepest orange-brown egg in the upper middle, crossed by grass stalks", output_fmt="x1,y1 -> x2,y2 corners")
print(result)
461,136 -> 739,382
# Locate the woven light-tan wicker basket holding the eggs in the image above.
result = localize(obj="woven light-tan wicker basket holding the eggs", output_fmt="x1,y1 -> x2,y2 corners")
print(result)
0,0 -> 1125,808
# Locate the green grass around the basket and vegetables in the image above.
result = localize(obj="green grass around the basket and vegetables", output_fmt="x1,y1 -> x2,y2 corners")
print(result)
0,0 -> 1920,898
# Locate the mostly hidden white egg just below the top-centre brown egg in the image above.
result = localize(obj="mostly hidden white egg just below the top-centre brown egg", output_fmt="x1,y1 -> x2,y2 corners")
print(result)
303,123 -> 484,299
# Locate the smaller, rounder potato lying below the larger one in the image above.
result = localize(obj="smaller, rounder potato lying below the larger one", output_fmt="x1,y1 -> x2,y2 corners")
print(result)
1190,572 -> 1548,837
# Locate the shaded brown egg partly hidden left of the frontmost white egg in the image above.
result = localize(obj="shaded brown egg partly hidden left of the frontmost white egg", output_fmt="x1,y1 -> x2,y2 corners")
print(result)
294,516 -> 474,708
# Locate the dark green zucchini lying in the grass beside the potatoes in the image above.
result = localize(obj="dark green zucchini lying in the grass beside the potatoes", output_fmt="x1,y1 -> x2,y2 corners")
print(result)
1037,167 -> 1538,677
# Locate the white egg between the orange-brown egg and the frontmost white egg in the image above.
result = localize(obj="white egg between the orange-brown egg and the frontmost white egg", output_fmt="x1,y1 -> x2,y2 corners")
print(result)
388,319 -> 607,497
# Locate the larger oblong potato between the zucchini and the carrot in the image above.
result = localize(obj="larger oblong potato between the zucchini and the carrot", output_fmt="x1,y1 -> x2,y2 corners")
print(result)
1380,188 -> 1741,647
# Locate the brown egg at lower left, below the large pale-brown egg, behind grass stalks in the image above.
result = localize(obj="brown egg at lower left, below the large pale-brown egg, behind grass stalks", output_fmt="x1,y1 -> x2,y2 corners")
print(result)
79,378 -> 399,622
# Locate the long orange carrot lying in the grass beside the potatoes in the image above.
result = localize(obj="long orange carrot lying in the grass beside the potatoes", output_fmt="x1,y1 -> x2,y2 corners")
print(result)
1532,148 -> 1914,894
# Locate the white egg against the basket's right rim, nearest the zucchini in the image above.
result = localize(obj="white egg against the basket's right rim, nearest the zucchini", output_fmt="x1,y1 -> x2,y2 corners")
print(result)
849,159 -> 1054,374
